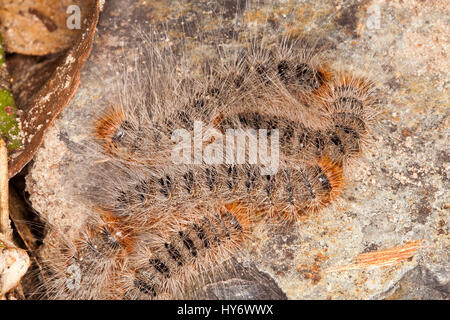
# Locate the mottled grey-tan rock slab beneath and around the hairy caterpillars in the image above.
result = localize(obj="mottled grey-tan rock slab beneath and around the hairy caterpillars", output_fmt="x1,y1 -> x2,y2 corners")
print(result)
27,0 -> 450,299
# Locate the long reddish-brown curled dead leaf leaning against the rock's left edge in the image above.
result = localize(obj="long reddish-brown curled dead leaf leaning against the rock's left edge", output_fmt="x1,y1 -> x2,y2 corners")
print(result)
9,1 -> 99,177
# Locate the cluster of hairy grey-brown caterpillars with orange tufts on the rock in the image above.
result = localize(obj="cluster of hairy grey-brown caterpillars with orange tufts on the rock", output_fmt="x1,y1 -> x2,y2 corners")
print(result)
35,33 -> 376,299
